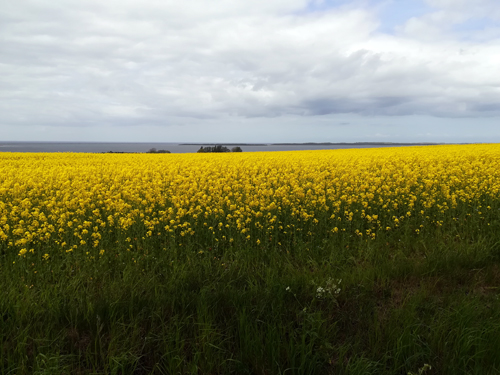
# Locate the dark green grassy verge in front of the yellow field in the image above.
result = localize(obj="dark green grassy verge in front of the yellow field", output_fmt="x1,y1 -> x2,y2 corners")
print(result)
0,221 -> 500,375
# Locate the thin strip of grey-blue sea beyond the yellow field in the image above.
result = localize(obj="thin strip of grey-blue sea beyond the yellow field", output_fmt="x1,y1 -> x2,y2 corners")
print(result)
0,142 -> 418,153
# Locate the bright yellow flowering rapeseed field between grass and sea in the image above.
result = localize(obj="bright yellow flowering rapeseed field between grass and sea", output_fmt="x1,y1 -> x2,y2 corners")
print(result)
0,144 -> 500,259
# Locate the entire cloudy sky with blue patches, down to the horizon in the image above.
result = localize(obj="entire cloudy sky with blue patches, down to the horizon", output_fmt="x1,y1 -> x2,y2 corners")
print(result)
0,0 -> 500,142
